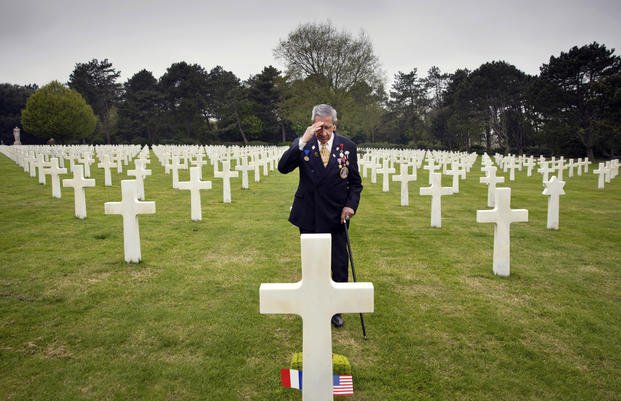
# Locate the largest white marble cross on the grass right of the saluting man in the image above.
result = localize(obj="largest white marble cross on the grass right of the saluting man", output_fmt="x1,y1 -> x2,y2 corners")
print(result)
477,188 -> 528,277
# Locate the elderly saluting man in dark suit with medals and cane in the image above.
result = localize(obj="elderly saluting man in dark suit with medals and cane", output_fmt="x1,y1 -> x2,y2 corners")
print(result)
278,104 -> 362,327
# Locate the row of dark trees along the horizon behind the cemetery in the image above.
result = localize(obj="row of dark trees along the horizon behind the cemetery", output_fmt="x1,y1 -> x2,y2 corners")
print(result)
0,22 -> 621,158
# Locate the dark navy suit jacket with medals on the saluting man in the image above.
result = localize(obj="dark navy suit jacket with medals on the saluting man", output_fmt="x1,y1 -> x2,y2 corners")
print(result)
278,133 -> 362,233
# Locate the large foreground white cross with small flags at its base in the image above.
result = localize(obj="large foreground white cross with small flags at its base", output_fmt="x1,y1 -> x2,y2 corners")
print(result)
259,234 -> 373,401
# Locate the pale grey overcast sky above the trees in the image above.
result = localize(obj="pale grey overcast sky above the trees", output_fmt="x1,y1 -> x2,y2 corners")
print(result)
0,0 -> 621,85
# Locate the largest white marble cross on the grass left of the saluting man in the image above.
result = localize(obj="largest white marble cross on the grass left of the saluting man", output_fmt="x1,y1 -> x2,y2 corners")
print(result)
104,180 -> 155,263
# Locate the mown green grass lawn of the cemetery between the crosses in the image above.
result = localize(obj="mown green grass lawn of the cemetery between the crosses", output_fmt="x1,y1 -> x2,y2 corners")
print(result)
0,151 -> 621,401
